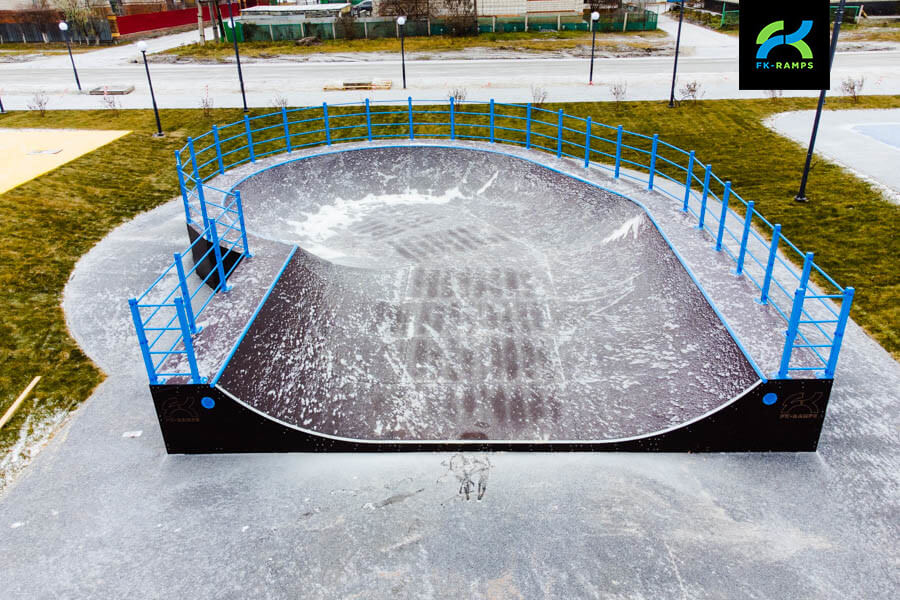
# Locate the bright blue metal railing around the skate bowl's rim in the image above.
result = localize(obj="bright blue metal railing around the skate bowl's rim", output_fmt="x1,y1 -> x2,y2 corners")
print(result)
131,98 -> 854,383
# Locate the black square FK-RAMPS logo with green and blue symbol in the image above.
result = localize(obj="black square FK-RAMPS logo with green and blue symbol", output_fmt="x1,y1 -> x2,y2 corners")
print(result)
740,0 -> 830,90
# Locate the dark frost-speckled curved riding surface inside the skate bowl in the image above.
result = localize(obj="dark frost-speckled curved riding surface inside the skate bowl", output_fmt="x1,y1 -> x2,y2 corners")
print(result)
219,147 -> 758,440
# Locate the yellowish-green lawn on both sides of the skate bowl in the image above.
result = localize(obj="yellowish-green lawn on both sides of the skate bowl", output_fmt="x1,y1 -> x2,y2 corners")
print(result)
0,96 -> 900,454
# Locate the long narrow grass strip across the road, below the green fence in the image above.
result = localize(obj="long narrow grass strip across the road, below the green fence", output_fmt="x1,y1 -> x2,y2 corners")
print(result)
163,31 -> 667,60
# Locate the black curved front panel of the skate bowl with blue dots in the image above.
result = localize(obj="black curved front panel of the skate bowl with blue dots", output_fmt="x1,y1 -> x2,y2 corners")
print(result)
151,379 -> 832,454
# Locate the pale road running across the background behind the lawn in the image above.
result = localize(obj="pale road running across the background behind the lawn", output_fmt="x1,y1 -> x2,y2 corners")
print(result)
0,47 -> 900,109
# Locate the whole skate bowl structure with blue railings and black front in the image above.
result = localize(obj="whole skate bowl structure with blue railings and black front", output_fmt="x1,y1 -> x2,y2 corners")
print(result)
129,99 -> 853,452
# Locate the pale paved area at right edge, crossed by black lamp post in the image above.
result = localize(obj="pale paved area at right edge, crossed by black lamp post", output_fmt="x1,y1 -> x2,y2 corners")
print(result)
766,109 -> 900,204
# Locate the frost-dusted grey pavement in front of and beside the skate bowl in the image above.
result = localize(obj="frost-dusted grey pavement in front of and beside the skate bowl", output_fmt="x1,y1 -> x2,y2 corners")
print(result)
0,142 -> 900,600
